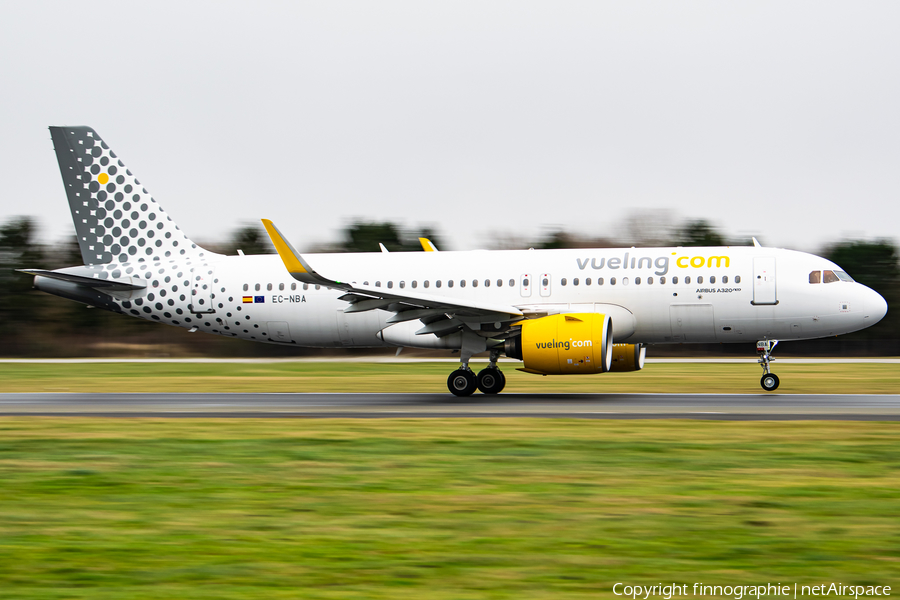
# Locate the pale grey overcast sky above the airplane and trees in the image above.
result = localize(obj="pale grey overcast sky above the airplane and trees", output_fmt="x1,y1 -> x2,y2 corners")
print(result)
0,1 -> 900,250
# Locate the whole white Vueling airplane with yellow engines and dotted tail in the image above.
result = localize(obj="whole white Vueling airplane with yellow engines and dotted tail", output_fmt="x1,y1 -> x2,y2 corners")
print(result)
20,127 -> 887,396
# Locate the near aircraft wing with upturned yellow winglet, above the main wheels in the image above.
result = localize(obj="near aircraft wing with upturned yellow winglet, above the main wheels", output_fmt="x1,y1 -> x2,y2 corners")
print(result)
262,219 -> 523,336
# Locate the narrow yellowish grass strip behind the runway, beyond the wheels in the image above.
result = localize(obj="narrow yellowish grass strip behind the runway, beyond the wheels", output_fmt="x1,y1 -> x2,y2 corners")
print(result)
0,362 -> 900,394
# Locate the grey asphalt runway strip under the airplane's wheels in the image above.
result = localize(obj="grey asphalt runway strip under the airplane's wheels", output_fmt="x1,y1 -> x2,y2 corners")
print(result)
0,393 -> 900,421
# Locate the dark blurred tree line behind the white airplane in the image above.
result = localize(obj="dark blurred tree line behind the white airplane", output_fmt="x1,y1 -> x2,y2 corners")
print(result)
0,216 -> 900,356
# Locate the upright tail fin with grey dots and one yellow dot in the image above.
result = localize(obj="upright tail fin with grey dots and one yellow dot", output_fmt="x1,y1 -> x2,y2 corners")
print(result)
50,127 -> 208,265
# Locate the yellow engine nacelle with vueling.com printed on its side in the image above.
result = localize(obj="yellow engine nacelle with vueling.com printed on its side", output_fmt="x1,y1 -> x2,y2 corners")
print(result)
505,313 -> 613,375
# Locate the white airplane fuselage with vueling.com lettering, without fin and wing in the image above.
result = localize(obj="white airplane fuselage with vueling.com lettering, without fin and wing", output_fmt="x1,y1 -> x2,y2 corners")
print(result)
42,247 -> 886,348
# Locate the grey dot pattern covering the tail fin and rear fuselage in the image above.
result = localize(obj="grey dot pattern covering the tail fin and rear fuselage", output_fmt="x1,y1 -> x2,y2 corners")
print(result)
51,127 -> 282,340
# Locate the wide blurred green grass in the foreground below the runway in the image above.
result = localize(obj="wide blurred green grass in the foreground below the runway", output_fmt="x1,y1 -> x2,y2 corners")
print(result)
0,418 -> 900,600
